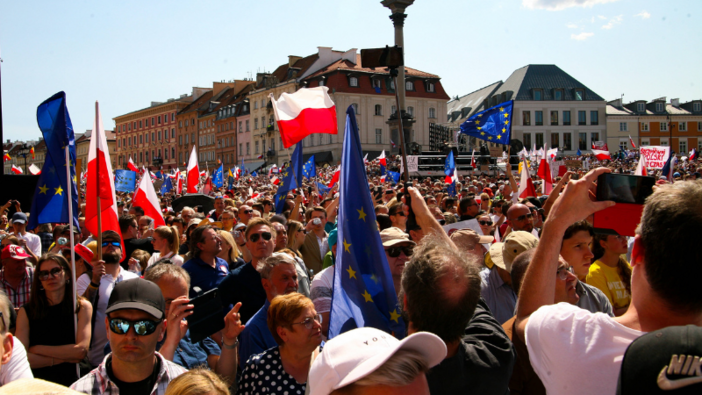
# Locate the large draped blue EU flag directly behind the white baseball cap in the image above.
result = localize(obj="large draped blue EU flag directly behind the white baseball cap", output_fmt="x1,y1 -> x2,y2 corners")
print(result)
329,106 -> 405,339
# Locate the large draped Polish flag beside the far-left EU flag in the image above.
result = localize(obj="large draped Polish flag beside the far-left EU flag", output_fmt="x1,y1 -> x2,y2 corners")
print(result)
85,102 -> 124,251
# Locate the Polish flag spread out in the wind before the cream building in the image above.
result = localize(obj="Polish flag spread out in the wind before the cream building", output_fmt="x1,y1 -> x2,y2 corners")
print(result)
271,86 -> 338,148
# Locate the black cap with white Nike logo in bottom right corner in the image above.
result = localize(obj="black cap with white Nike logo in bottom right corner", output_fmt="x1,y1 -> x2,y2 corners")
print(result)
617,325 -> 702,395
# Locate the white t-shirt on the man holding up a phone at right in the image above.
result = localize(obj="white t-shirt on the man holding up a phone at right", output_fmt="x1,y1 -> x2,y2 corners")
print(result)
525,303 -> 644,395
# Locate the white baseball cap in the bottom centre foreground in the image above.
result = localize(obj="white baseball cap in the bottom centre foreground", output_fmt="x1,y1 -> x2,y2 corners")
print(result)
307,328 -> 446,395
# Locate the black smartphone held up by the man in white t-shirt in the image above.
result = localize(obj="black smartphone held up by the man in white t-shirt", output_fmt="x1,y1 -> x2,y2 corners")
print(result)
597,173 -> 656,204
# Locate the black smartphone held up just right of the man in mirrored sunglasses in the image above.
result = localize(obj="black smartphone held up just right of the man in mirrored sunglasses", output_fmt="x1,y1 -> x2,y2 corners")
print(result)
186,288 -> 224,343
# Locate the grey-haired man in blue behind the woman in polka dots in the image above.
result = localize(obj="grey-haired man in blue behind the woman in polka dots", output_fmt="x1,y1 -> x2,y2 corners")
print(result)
239,252 -> 298,366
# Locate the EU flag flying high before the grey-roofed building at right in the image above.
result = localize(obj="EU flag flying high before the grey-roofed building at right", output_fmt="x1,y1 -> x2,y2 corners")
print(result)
460,100 -> 514,144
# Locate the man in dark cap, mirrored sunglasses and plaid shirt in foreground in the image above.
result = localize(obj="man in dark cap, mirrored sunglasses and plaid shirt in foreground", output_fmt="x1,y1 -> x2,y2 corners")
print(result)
71,278 -> 187,394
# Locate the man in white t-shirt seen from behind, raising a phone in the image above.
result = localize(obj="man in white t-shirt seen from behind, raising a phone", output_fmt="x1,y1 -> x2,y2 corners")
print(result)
516,168 -> 702,394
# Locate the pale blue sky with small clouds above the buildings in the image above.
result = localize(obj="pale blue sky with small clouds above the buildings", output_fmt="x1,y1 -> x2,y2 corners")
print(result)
0,0 -> 702,141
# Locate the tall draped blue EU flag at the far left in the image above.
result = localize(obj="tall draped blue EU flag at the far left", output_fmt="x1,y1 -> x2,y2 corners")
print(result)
27,92 -> 79,229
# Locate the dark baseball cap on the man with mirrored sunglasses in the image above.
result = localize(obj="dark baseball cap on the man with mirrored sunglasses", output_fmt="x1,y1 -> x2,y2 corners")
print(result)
105,278 -> 166,320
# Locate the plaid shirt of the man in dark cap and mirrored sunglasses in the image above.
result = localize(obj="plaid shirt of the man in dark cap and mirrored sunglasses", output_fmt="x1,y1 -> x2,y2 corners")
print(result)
71,352 -> 188,395
